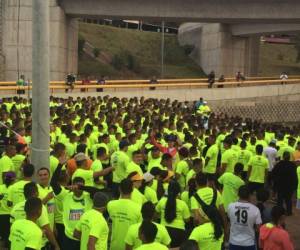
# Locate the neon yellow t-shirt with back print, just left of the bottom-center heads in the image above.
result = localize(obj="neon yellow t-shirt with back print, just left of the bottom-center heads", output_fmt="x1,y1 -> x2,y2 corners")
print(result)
107,199 -> 141,250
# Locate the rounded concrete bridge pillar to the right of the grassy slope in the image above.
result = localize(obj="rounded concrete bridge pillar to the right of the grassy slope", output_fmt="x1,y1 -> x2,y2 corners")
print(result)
179,24 -> 259,77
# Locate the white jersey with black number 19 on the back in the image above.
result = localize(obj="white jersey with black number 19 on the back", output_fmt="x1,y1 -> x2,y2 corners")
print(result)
227,201 -> 262,246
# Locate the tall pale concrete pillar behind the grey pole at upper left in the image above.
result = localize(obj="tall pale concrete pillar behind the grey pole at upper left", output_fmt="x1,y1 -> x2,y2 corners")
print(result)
1,0 -> 78,81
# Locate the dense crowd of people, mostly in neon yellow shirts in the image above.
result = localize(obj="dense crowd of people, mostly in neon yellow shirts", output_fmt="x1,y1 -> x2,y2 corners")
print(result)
0,96 -> 300,250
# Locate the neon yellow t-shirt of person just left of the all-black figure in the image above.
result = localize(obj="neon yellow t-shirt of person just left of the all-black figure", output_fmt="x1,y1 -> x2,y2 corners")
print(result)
249,155 -> 269,183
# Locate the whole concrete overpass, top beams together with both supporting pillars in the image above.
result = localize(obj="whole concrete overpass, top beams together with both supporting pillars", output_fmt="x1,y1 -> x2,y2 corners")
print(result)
0,0 -> 300,80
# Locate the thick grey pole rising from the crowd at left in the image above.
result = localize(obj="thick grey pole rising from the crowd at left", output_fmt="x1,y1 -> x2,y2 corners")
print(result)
31,0 -> 50,169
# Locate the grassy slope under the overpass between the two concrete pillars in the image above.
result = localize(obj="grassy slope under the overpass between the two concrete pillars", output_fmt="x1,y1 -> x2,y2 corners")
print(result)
79,23 -> 204,79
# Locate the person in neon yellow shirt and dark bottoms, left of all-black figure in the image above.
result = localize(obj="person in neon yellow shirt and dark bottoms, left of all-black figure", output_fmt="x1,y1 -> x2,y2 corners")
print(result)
248,144 -> 269,193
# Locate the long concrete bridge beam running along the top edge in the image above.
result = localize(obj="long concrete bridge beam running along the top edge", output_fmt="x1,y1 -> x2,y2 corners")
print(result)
59,0 -> 300,23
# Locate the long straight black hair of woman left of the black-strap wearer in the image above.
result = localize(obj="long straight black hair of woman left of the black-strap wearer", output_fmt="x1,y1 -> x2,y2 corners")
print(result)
165,181 -> 180,223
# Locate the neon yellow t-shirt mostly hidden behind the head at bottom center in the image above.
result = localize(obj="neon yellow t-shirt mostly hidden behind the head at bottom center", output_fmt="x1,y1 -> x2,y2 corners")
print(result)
125,222 -> 171,250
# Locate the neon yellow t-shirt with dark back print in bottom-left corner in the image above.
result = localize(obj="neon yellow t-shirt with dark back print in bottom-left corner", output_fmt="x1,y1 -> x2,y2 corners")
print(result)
9,219 -> 43,250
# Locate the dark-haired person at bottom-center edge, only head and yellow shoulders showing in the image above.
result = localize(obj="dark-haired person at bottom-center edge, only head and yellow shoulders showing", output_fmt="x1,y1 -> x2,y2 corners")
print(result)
136,221 -> 168,250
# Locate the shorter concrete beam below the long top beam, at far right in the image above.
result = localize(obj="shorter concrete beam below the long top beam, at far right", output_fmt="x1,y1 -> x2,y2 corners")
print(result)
230,23 -> 300,36
